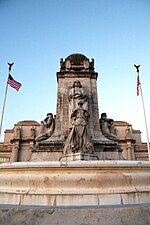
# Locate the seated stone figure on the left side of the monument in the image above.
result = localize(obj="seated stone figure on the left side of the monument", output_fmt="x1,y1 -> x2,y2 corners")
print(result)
35,113 -> 55,143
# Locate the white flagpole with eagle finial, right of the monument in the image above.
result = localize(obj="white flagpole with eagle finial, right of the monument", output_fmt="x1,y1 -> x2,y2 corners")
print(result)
134,65 -> 150,161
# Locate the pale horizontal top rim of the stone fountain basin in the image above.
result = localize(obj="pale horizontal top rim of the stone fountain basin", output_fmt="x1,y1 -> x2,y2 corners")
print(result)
0,160 -> 150,169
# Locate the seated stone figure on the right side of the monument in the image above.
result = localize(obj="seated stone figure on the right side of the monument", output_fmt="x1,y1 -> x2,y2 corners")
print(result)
100,113 -> 118,141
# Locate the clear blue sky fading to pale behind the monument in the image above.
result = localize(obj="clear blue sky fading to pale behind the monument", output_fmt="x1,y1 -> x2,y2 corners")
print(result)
0,0 -> 150,142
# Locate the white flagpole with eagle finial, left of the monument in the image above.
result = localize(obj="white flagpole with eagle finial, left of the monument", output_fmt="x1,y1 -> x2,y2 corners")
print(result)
0,63 -> 14,137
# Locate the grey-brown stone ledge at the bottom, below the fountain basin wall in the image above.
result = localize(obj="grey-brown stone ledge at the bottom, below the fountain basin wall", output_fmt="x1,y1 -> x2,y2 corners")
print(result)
0,204 -> 150,225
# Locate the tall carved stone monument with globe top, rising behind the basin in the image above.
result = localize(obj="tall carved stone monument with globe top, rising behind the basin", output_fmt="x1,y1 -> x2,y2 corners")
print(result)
31,54 -> 123,161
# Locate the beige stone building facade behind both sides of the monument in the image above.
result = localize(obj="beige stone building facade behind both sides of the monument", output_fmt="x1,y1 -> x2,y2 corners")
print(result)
0,120 -> 148,163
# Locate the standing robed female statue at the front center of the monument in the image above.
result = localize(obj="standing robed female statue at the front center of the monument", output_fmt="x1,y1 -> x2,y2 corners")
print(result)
63,100 -> 93,154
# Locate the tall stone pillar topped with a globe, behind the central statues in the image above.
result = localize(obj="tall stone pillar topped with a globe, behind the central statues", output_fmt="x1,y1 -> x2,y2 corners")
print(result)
49,54 -> 108,142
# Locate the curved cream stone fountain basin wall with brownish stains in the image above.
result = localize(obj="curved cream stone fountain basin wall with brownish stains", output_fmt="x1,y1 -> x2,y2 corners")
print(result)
0,160 -> 150,206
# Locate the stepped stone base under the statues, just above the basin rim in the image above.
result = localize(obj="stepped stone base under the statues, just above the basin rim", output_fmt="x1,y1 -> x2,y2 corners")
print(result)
30,140 -> 124,161
